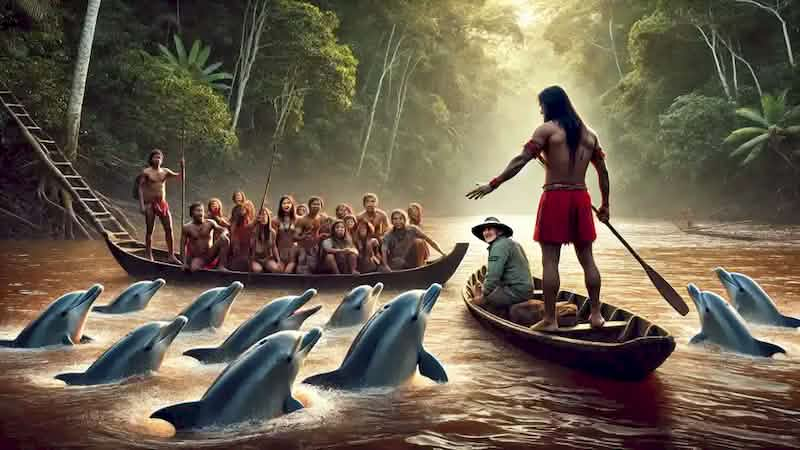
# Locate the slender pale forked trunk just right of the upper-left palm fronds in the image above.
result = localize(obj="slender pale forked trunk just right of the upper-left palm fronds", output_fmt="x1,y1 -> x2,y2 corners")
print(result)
231,0 -> 267,131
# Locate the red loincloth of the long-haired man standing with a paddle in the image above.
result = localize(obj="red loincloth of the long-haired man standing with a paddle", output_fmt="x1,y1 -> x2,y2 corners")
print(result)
533,189 -> 597,244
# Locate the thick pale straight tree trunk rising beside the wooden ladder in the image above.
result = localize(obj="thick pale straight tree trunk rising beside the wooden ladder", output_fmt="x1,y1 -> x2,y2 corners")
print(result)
64,0 -> 100,161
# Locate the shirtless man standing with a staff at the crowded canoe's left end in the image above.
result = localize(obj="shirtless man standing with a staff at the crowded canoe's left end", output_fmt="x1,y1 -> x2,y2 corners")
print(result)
137,149 -> 184,264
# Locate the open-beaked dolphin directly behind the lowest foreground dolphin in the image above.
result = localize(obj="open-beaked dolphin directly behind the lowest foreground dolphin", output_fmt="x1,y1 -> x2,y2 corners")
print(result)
183,289 -> 322,364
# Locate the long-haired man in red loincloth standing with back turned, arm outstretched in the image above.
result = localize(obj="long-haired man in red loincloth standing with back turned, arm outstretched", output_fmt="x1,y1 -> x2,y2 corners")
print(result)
467,86 -> 609,330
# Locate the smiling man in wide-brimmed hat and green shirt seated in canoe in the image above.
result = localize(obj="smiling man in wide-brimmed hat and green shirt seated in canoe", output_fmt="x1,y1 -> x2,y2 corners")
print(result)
472,217 -> 533,315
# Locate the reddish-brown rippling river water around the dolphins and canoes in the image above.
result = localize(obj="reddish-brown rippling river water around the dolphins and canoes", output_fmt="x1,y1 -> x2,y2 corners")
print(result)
0,216 -> 800,449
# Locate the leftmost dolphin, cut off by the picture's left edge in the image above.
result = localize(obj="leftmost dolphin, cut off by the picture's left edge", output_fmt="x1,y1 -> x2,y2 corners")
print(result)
0,284 -> 103,348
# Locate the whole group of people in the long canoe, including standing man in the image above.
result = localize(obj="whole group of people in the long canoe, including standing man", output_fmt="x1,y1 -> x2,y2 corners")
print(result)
136,150 -> 444,275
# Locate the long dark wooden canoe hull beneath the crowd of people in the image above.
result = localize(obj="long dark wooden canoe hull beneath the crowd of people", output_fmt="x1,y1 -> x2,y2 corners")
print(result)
104,230 -> 469,289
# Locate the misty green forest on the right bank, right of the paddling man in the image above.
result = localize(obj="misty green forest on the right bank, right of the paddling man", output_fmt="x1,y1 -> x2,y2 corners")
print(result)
537,0 -> 800,219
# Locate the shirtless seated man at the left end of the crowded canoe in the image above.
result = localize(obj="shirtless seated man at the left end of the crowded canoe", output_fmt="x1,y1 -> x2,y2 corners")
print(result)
181,202 -> 231,272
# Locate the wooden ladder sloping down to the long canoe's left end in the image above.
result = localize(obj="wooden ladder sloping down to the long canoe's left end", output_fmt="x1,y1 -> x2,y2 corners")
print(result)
0,83 -> 134,242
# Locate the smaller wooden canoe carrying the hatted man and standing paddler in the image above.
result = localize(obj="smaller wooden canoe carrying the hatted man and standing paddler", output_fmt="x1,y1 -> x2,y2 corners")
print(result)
462,266 -> 675,380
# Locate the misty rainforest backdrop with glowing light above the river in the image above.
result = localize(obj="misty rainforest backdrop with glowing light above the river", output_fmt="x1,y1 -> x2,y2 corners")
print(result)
0,0 -> 800,229
